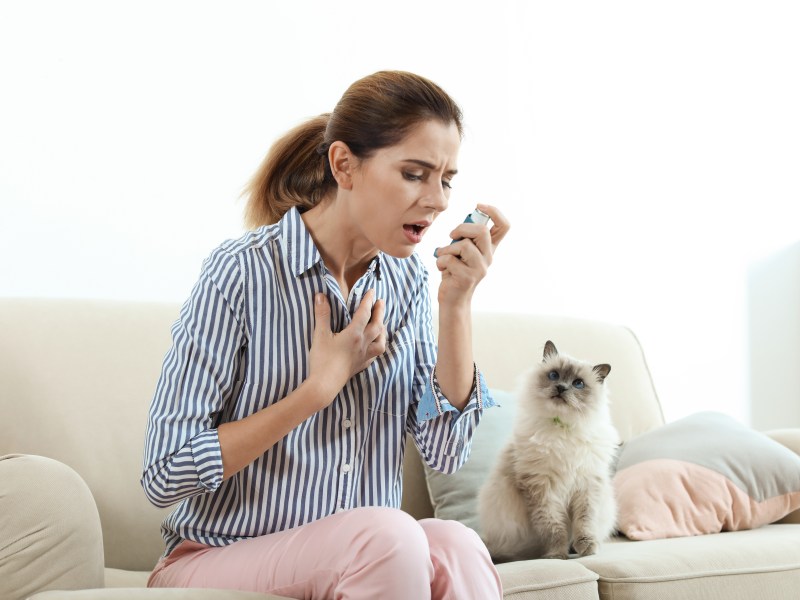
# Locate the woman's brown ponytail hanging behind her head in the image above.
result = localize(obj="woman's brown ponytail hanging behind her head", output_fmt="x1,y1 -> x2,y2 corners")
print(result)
244,114 -> 336,229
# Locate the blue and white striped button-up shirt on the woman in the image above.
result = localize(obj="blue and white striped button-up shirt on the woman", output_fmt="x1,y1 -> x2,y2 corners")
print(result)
142,209 -> 494,554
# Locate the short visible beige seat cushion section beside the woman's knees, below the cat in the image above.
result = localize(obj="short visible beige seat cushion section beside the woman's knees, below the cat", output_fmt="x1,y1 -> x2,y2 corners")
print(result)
497,559 -> 598,600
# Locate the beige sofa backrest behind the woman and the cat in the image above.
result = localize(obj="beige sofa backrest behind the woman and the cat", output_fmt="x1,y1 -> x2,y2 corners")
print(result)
0,299 -> 663,570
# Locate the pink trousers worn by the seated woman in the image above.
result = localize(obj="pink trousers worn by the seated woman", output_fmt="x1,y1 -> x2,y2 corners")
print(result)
148,507 -> 503,600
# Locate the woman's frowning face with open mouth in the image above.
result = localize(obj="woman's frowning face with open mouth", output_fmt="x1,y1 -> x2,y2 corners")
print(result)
350,120 -> 461,258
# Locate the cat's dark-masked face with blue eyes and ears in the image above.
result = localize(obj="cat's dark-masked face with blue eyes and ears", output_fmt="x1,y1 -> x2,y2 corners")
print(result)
533,341 -> 611,414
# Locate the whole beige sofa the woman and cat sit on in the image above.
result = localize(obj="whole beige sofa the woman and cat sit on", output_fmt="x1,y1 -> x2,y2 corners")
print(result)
0,299 -> 800,600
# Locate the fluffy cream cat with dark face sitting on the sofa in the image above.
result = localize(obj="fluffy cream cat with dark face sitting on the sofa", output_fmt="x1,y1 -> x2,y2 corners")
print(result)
478,341 -> 619,562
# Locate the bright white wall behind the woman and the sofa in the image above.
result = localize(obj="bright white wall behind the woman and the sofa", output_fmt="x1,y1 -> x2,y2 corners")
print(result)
0,0 -> 800,420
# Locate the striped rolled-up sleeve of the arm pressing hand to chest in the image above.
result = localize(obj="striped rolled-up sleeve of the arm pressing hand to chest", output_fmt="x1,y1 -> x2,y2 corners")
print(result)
141,248 -> 246,507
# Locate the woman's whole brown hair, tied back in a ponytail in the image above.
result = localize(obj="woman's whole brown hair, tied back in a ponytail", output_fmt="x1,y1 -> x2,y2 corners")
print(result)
244,71 -> 463,228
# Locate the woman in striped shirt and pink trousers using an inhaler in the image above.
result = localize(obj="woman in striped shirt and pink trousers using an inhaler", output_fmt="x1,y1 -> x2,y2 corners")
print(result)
142,72 -> 509,599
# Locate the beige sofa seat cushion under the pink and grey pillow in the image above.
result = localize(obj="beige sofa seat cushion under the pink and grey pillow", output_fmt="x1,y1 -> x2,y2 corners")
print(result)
577,525 -> 800,600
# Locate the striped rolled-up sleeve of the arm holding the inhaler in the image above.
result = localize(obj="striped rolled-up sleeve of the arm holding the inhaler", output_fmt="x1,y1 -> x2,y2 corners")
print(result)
409,268 -> 495,473
